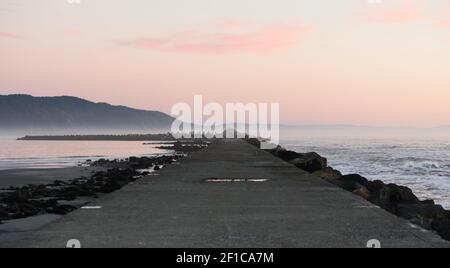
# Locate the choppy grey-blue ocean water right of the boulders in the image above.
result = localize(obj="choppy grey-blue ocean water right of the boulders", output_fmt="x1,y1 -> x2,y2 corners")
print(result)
282,137 -> 450,209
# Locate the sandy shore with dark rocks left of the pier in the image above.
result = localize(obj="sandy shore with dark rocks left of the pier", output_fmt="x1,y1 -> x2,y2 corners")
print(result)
0,141 -> 207,235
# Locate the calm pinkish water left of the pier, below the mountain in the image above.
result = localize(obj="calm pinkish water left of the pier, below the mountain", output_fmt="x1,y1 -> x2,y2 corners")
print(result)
0,139 -> 168,170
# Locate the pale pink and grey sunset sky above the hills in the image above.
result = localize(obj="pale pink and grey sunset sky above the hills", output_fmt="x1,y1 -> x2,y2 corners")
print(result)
0,0 -> 450,127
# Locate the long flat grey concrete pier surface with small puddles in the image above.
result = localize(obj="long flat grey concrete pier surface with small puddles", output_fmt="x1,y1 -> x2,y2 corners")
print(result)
0,140 -> 449,248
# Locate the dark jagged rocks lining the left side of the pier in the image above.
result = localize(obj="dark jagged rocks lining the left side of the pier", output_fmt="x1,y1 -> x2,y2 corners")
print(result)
0,140 -> 208,224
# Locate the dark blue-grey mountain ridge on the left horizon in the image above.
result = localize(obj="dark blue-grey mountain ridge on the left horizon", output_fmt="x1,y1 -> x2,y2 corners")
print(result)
0,94 -> 175,133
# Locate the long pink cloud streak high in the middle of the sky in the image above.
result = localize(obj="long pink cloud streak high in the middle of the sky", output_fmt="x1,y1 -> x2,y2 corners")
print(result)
120,24 -> 309,54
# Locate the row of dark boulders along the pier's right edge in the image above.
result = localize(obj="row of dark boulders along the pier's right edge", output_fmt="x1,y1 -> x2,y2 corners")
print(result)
248,139 -> 450,240
